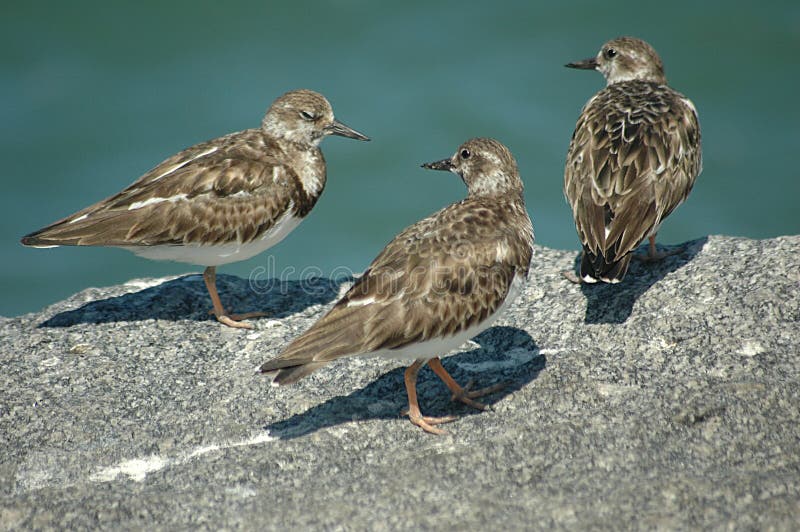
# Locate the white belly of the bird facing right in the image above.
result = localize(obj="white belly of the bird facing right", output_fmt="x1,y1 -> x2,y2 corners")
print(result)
120,213 -> 303,266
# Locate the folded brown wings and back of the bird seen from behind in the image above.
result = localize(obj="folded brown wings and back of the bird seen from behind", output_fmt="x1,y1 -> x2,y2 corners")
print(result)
564,82 -> 701,262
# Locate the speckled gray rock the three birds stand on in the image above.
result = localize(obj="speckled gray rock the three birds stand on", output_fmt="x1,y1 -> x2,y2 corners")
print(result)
0,236 -> 800,530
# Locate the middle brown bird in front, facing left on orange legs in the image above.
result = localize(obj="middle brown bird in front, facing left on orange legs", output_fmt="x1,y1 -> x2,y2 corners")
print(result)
260,138 -> 533,434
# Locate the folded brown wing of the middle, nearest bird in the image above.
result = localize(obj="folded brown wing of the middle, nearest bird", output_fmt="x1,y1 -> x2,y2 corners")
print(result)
262,199 -> 533,376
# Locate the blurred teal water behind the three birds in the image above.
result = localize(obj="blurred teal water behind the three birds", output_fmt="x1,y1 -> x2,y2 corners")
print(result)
0,0 -> 800,316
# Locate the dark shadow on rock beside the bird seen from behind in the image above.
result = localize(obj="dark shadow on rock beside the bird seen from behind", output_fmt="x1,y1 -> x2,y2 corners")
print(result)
573,237 -> 708,324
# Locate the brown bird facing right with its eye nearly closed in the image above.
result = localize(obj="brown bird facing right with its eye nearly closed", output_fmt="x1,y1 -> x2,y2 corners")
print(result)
21,89 -> 370,329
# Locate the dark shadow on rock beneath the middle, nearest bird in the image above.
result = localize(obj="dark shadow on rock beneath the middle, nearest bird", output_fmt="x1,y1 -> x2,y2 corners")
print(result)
265,326 -> 547,439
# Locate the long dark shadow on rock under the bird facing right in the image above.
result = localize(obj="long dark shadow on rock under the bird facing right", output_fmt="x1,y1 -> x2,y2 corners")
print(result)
37,274 -> 352,328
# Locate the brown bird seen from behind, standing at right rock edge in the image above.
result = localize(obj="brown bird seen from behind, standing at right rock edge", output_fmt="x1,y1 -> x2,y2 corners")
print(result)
564,37 -> 702,283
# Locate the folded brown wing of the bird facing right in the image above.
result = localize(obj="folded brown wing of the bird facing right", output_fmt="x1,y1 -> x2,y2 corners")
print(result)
23,130 -> 309,246
